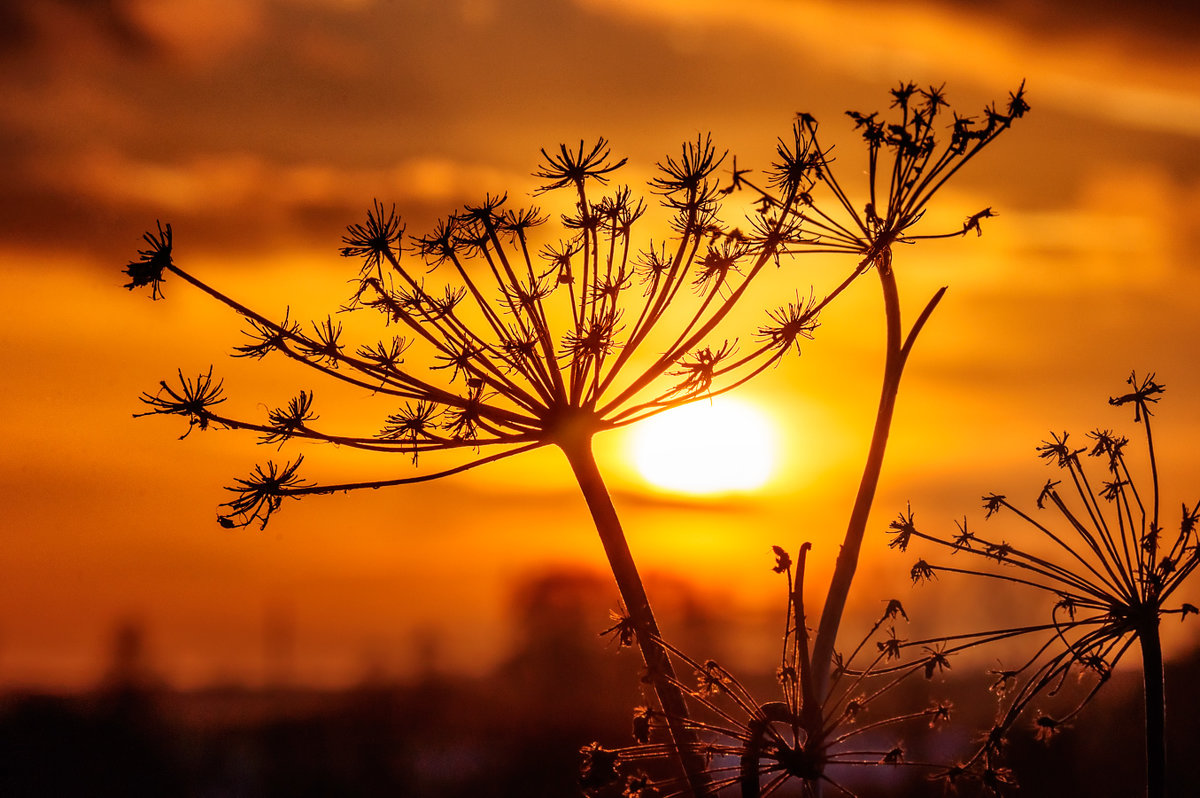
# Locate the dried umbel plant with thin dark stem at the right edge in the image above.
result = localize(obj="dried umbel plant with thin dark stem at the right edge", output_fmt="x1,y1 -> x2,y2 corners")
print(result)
892,374 -> 1200,798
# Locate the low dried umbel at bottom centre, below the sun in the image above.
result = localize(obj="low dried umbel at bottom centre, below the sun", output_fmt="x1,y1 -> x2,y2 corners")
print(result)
581,544 -> 950,798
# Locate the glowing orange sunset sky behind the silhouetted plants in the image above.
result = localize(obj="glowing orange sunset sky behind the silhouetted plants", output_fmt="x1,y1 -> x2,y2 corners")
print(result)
0,0 -> 1200,686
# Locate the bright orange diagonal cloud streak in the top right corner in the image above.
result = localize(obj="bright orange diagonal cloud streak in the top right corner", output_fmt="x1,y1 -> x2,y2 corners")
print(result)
577,0 -> 1200,138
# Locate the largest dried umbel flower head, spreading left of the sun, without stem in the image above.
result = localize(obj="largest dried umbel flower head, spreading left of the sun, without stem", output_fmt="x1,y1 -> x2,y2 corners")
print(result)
127,138 -> 832,526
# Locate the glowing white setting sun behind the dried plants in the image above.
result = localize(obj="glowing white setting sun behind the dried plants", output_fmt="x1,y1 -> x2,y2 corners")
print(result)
630,396 -> 779,496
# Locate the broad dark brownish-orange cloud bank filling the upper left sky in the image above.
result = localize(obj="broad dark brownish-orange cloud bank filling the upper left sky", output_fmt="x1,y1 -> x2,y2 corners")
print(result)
0,0 -> 788,251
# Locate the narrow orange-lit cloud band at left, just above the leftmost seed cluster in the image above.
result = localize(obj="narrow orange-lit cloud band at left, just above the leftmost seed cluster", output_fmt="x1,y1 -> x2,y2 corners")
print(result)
0,149 -> 534,258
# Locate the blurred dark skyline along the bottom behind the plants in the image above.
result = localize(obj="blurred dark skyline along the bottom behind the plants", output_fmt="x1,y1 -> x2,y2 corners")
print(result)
0,571 -> 1200,798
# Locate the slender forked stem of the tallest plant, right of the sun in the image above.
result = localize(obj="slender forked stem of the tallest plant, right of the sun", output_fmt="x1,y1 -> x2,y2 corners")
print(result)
812,263 -> 902,700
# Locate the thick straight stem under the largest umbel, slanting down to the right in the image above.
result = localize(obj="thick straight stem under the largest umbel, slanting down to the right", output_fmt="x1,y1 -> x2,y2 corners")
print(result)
558,436 -> 710,798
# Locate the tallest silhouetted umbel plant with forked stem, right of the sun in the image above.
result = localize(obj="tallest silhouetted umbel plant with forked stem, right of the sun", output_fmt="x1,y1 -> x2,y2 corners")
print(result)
715,83 -> 1030,720
